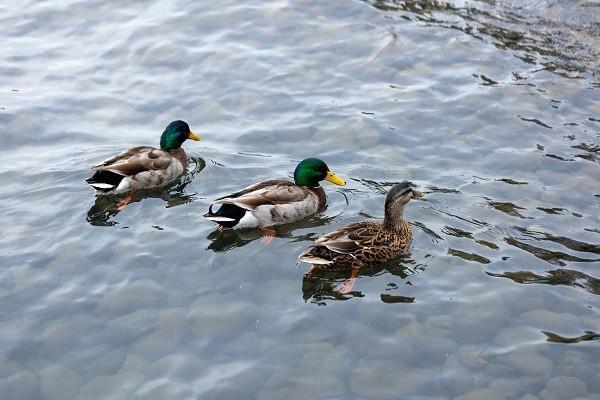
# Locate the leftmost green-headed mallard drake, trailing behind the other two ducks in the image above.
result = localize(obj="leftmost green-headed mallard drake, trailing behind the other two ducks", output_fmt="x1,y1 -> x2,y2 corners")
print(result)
85,120 -> 200,209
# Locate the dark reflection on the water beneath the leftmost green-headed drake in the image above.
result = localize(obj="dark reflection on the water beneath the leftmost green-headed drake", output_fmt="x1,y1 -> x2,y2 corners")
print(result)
86,158 -> 206,226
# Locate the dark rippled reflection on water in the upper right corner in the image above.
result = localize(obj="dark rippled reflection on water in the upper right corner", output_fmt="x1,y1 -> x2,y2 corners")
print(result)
367,0 -> 600,80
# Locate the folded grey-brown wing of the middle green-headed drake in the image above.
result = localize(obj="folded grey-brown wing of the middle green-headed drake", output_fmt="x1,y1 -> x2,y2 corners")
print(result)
215,179 -> 311,210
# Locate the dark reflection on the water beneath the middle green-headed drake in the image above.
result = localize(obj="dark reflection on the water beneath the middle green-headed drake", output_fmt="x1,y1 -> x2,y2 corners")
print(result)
206,214 -> 337,253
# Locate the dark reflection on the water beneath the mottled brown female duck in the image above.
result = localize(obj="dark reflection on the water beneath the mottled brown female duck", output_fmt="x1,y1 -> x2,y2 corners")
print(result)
302,254 -> 425,305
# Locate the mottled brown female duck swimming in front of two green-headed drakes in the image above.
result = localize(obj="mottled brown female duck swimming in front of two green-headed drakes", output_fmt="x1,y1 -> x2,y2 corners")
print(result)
298,181 -> 424,290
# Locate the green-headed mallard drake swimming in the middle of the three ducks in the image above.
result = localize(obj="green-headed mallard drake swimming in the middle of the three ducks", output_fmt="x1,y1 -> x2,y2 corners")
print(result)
204,158 -> 346,236
